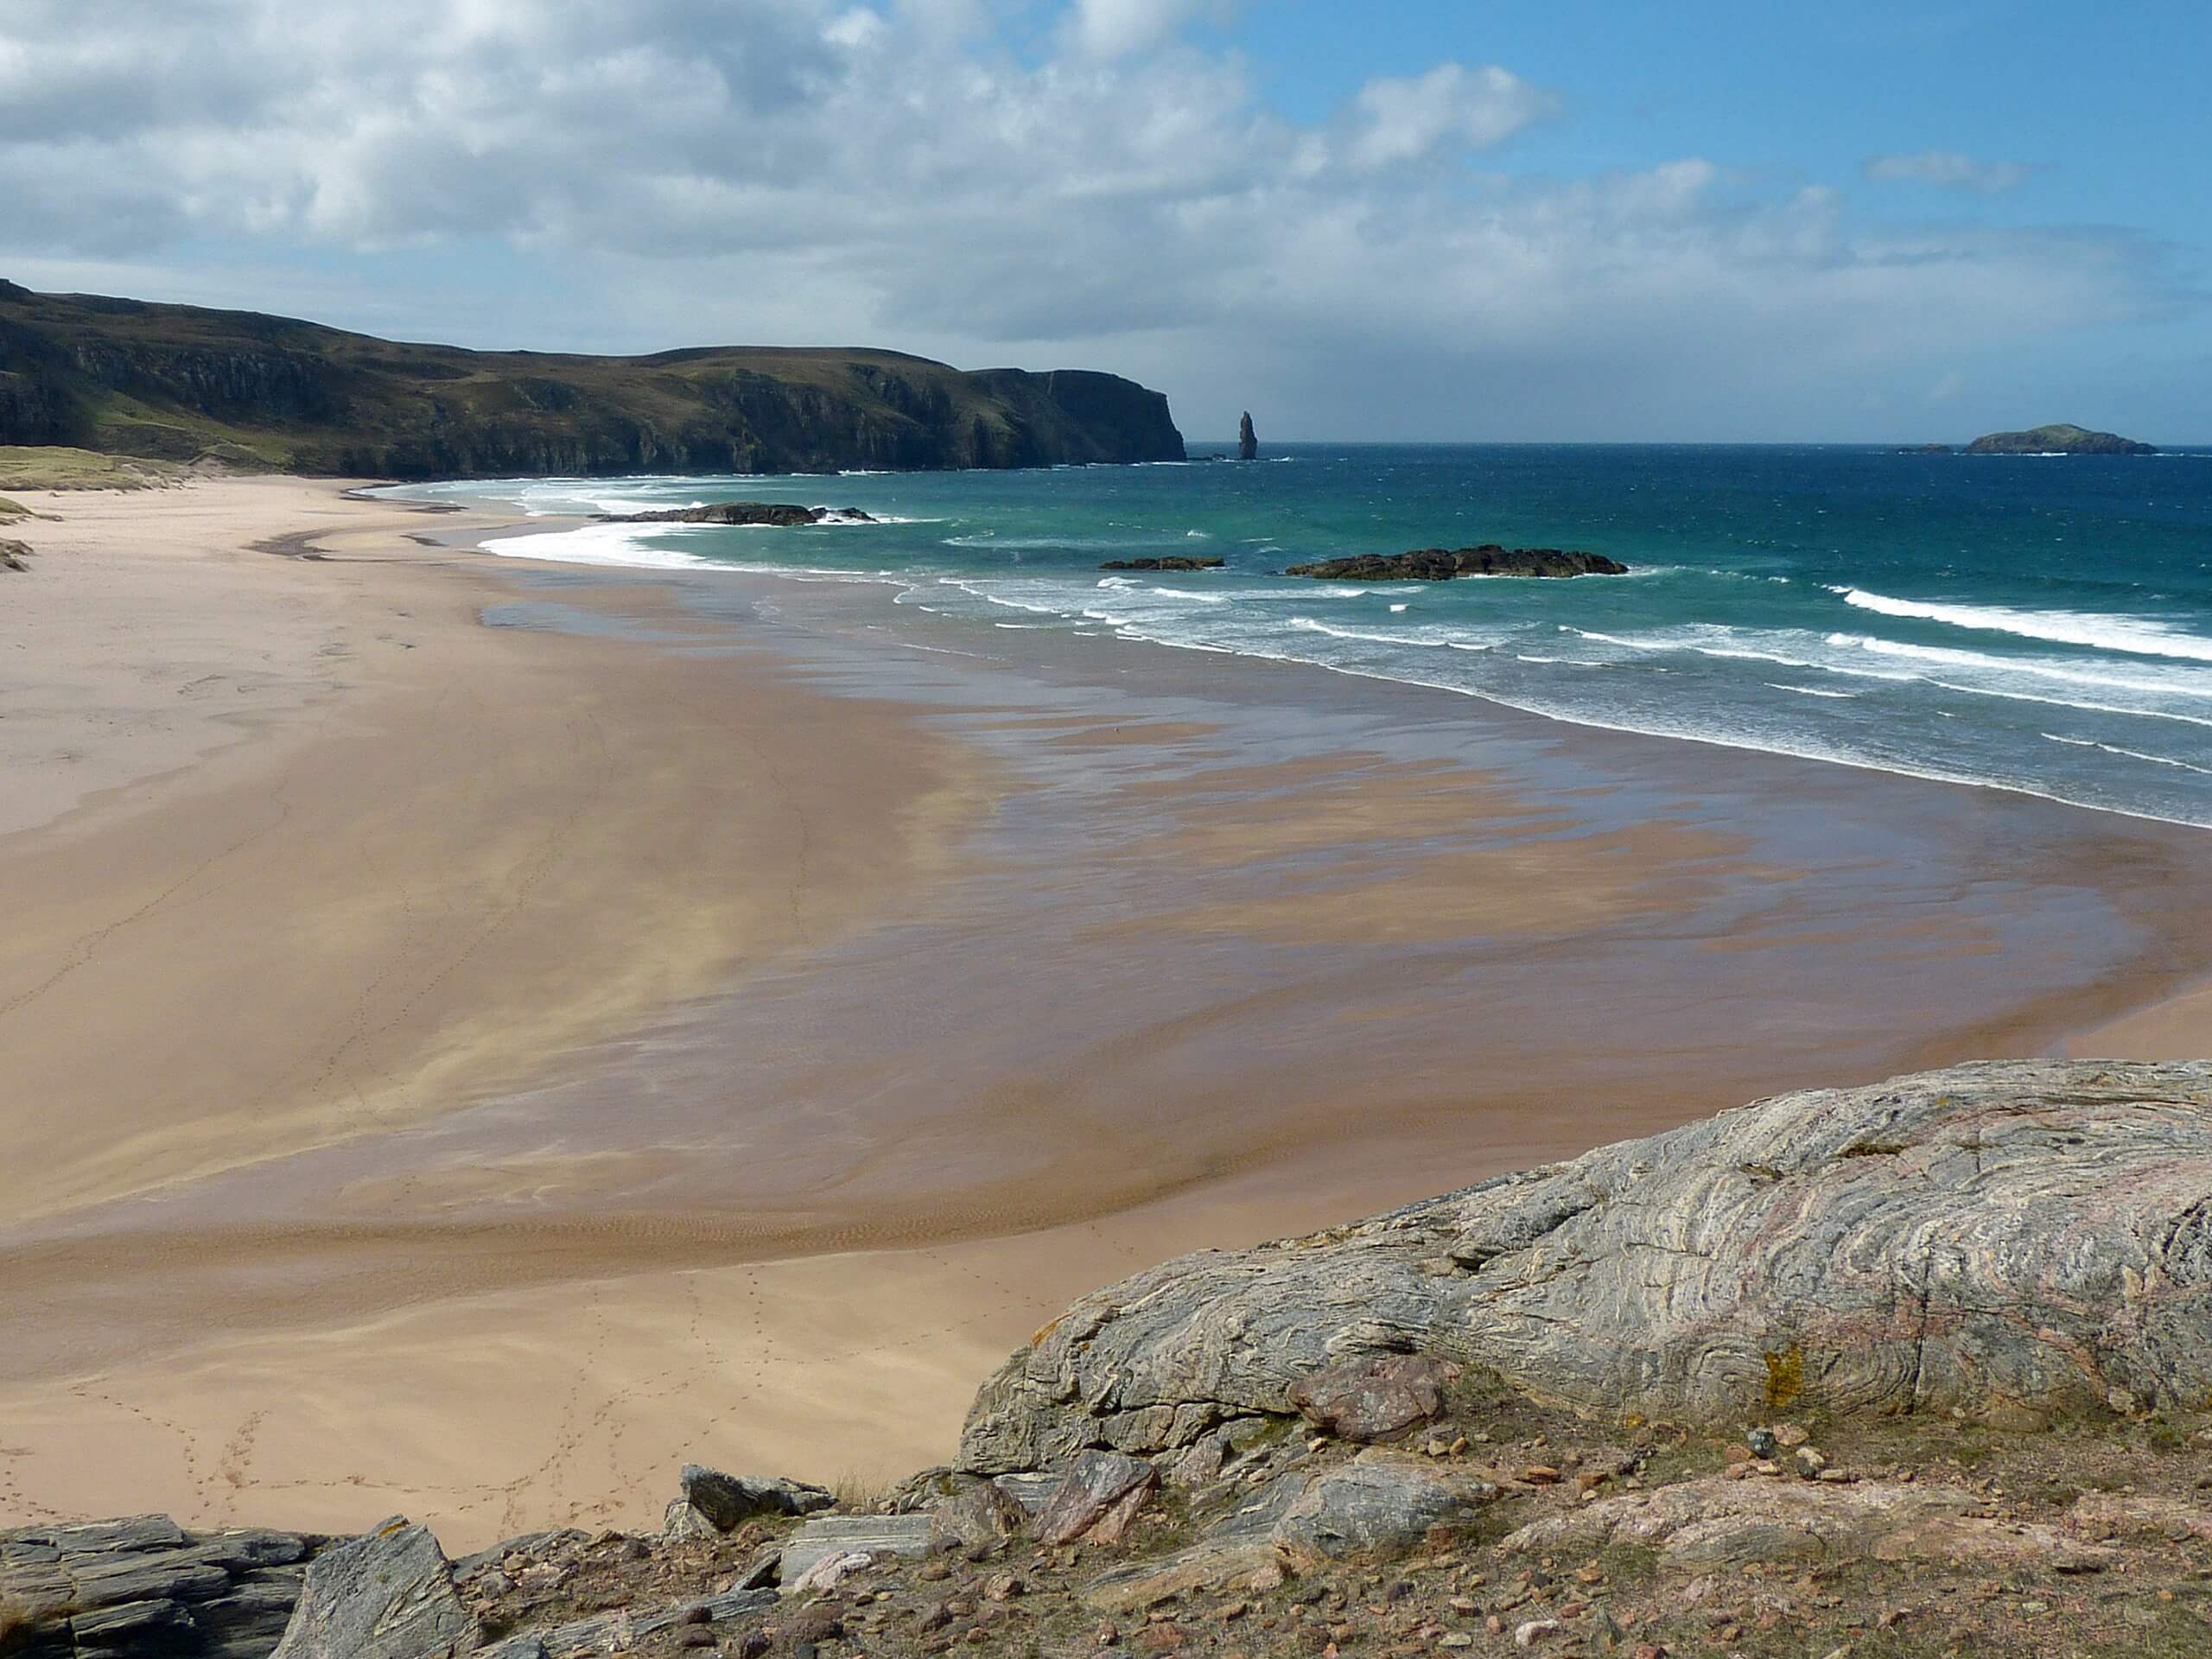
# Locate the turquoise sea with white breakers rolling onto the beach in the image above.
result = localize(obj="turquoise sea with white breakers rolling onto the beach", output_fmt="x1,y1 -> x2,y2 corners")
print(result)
389,445 -> 2212,825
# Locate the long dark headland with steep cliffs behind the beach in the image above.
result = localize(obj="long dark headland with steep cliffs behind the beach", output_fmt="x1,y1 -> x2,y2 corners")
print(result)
0,281 -> 1184,478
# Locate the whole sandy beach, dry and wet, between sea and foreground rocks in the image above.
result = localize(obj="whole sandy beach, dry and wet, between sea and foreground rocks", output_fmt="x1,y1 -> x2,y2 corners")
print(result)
0,478 -> 2212,1548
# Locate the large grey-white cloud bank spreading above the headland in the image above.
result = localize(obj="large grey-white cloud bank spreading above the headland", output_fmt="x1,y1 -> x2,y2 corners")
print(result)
0,0 -> 2190,435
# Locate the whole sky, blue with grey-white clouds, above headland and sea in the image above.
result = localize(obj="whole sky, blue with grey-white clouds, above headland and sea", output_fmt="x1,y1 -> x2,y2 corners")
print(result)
0,0 -> 2212,442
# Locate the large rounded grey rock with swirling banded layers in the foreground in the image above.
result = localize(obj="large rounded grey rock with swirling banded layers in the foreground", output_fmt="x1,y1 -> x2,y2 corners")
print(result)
960,1062 -> 2212,1473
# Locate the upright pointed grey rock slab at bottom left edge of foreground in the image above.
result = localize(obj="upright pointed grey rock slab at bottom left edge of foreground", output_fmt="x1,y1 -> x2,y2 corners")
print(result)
272,1516 -> 482,1659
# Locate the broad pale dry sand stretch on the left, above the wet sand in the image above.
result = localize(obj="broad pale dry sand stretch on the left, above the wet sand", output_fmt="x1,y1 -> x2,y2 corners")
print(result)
0,480 -> 982,1225
